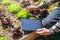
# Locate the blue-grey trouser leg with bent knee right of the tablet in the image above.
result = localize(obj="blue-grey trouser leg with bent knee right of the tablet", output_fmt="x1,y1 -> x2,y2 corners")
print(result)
43,9 -> 60,28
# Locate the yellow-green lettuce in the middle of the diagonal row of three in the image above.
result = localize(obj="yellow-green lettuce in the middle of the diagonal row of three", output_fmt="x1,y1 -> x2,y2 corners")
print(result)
7,4 -> 21,13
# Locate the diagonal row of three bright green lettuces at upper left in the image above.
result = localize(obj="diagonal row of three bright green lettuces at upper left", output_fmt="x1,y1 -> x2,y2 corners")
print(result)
2,0 -> 34,19
